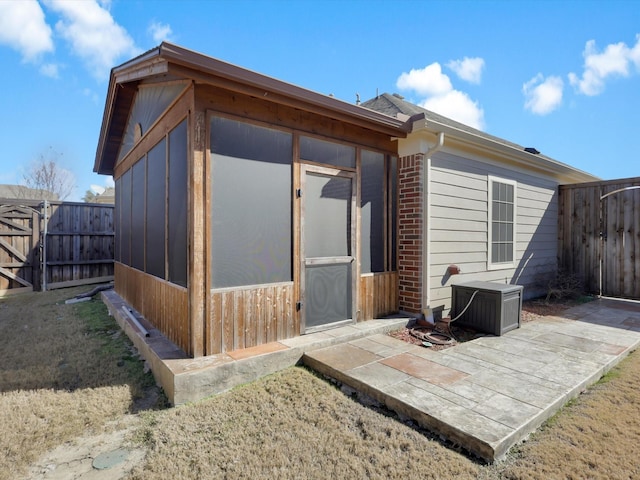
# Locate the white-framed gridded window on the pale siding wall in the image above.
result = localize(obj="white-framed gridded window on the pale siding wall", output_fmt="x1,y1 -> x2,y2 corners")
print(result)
487,176 -> 518,270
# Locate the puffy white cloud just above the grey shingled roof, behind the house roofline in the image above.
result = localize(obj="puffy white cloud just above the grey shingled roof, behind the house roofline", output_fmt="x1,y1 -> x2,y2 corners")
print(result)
396,62 -> 485,130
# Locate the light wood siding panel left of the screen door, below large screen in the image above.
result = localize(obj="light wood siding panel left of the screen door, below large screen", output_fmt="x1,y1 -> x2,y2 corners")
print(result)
206,283 -> 295,354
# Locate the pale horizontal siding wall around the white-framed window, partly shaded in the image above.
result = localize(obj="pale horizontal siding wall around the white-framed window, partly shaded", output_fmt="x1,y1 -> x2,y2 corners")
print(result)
429,152 -> 558,314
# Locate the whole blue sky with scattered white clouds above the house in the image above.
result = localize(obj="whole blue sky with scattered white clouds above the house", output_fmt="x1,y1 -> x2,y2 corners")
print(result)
0,0 -> 640,200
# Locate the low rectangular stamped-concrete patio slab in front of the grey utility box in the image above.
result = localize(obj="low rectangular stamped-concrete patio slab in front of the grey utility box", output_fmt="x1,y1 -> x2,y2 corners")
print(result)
303,299 -> 640,462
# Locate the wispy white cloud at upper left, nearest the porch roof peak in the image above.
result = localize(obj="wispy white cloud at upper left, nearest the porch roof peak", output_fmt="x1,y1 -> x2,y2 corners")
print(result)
46,0 -> 139,79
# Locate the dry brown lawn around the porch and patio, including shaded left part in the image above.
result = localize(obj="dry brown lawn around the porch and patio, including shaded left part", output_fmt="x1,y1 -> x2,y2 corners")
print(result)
0,291 -> 640,480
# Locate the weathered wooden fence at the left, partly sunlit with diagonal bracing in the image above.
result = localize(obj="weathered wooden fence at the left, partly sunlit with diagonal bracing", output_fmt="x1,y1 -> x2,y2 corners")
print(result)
0,199 -> 114,295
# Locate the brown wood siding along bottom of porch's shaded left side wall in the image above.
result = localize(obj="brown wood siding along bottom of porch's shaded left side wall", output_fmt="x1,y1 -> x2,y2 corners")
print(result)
115,263 -> 193,355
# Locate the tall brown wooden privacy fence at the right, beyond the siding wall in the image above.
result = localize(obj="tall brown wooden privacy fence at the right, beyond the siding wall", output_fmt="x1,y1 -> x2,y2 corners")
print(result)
558,177 -> 640,299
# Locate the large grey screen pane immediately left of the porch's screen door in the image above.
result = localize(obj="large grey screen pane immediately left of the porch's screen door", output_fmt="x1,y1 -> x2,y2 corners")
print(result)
210,117 -> 293,288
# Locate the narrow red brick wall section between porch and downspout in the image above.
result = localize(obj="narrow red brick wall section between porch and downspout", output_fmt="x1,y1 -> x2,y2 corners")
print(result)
398,154 -> 424,313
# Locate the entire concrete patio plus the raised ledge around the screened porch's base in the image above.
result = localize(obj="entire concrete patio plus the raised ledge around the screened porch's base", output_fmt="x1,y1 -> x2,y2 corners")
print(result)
102,291 -> 640,461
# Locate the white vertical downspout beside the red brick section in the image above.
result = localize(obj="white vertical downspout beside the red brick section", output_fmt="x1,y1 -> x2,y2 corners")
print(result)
422,132 -> 444,321
